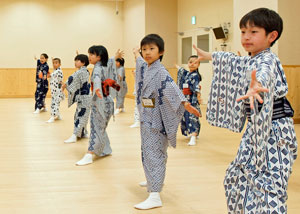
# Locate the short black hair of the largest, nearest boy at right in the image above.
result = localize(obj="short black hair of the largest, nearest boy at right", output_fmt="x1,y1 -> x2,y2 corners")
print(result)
240,8 -> 283,46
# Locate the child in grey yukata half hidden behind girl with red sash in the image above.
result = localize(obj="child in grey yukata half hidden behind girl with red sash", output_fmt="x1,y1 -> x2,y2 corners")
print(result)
115,58 -> 127,114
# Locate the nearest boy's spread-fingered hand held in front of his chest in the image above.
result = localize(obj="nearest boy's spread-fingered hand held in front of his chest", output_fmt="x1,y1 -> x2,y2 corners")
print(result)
236,70 -> 269,109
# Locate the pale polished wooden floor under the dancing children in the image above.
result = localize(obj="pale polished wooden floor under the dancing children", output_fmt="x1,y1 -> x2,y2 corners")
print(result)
0,99 -> 300,214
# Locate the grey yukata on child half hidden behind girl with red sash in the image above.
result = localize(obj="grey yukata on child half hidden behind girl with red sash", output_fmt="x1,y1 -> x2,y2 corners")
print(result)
116,66 -> 128,108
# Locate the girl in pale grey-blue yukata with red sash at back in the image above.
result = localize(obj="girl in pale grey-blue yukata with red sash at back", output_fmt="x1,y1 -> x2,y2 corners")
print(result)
76,46 -> 123,166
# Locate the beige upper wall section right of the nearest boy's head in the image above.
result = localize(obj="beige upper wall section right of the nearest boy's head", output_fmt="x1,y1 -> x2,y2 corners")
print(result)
278,0 -> 300,65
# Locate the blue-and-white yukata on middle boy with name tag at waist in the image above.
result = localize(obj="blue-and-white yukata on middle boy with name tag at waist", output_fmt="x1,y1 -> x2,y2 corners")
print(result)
136,57 -> 186,192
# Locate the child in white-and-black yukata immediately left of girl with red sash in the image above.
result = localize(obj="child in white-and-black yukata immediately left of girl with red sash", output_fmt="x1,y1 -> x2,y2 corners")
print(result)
62,54 -> 91,143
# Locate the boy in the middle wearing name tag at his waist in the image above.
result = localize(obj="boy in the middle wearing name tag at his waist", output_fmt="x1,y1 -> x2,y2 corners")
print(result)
134,34 -> 200,210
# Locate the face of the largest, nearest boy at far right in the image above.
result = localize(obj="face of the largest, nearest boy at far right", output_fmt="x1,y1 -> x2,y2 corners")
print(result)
241,23 -> 278,56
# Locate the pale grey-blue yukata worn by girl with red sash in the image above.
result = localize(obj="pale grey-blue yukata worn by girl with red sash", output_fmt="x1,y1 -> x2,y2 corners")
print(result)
88,58 -> 116,156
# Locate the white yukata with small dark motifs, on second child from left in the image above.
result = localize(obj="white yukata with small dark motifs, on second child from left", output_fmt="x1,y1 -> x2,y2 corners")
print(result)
50,68 -> 65,117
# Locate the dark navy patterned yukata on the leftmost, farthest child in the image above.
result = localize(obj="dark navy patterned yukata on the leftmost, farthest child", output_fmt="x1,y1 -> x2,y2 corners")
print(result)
34,60 -> 49,110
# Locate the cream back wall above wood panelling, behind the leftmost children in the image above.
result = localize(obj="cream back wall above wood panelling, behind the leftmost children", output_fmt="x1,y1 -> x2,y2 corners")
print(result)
0,0 -> 124,68
